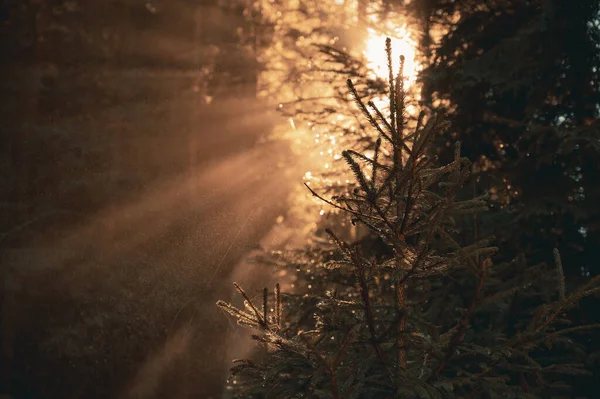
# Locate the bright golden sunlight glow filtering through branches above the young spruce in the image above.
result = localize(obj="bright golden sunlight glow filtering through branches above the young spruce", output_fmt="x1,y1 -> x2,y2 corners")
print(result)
258,0 -> 420,226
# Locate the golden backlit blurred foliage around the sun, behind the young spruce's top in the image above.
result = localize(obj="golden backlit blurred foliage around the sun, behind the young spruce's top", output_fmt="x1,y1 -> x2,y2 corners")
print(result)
246,0 -> 419,231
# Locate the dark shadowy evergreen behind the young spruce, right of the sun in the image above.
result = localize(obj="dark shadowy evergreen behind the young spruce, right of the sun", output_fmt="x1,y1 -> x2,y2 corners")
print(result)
409,0 -> 600,282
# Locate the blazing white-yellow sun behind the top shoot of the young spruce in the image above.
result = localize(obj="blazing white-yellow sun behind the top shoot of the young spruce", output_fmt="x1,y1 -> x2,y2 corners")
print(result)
363,26 -> 419,88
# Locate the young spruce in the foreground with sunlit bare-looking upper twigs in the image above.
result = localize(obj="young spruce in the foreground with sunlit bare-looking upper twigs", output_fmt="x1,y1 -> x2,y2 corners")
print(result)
218,41 -> 600,398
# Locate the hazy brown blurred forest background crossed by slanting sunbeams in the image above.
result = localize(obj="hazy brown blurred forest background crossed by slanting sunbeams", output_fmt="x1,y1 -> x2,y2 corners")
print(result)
0,0 -> 296,398
